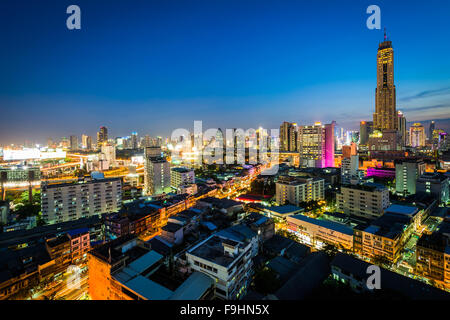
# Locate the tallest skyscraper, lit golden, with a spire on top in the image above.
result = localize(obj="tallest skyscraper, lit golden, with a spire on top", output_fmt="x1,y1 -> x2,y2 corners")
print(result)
373,32 -> 398,131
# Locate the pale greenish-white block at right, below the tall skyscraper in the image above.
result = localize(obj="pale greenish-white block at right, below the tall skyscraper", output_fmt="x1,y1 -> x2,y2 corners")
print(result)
395,160 -> 425,196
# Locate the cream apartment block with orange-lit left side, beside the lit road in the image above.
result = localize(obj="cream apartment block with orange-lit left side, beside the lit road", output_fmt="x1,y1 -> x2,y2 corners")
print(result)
275,176 -> 325,206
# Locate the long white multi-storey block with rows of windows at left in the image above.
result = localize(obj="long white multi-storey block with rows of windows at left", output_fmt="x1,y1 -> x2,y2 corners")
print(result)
41,174 -> 122,224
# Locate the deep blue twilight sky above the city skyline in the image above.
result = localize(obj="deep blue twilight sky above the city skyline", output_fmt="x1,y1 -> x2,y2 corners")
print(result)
0,0 -> 450,143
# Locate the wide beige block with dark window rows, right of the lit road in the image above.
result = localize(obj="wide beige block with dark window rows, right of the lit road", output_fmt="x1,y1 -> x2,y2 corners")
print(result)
336,183 -> 389,219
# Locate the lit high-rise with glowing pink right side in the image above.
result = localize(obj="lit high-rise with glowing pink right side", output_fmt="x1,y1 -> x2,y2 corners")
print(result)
298,121 -> 335,168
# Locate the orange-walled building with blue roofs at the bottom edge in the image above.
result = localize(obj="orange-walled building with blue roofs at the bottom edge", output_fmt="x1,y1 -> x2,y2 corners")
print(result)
88,235 -> 215,300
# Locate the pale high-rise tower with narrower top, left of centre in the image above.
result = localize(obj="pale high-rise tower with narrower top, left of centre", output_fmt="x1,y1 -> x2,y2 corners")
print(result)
144,147 -> 170,195
